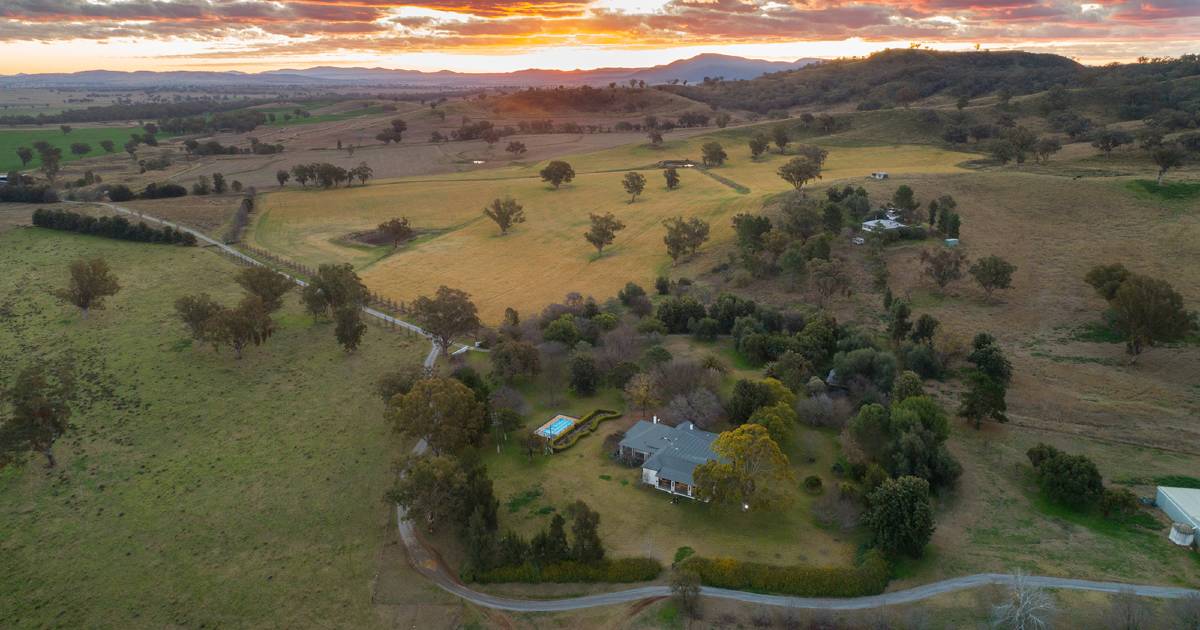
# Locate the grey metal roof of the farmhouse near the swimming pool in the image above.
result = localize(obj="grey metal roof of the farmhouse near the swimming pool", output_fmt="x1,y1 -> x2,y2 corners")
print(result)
620,420 -> 724,485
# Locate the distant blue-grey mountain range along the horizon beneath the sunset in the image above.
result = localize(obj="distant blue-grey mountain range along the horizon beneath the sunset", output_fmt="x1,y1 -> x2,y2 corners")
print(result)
0,54 -> 820,89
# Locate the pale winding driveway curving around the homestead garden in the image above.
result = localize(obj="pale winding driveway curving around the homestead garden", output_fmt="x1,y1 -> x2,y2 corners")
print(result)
71,202 -> 1200,612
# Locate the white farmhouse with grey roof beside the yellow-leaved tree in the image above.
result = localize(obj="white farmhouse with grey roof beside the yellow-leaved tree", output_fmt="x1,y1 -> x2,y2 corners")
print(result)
618,418 -> 722,498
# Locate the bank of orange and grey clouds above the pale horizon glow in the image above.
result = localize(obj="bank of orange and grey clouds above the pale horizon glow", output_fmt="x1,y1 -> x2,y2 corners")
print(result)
0,0 -> 1200,63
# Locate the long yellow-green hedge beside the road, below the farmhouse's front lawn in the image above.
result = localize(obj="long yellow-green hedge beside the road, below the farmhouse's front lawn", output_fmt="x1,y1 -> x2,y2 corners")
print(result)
684,551 -> 889,598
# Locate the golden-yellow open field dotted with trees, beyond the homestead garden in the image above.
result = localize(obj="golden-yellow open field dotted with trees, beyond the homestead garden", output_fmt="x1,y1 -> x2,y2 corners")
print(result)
247,137 -> 968,322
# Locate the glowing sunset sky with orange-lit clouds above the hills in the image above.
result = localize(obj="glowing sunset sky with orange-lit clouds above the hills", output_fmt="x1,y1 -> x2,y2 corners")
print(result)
0,0 -> 1200,74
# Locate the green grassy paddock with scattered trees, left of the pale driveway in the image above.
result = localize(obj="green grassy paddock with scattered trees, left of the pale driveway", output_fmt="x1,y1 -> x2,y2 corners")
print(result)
0,228 -> 429,628
